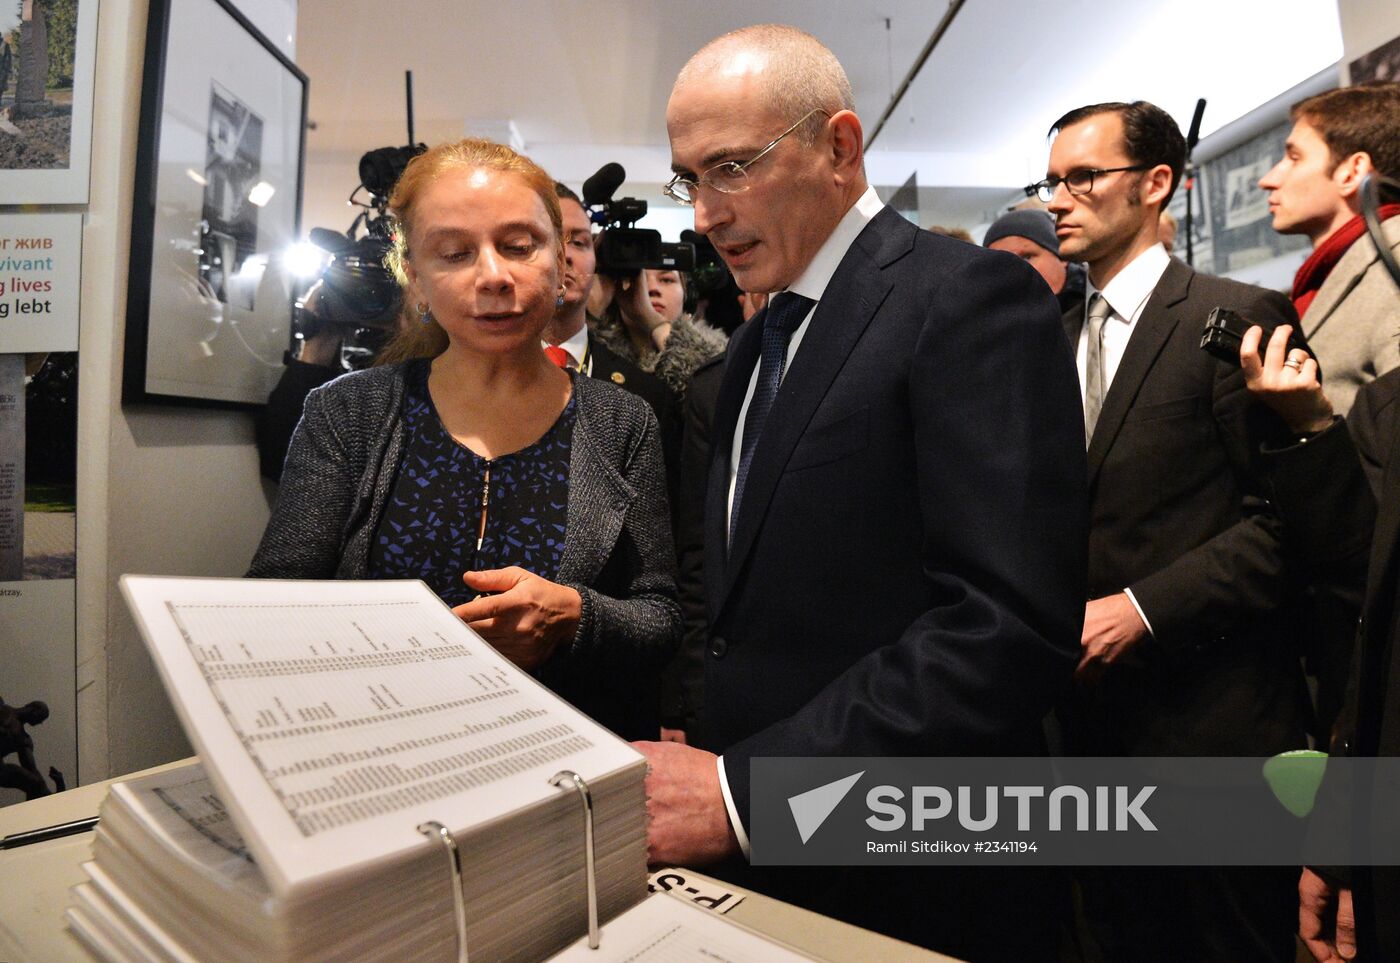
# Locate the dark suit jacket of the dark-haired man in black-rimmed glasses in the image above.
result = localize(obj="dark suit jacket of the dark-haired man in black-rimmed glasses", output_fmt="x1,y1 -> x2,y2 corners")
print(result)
1063,260 -> 1308,756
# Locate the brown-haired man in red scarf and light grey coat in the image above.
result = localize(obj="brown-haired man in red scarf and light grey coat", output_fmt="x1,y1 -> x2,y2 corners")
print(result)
1259,83 -> 1400,414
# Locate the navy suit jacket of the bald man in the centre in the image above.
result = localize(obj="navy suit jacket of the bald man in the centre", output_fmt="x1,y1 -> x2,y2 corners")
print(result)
704,209 -> 1085,952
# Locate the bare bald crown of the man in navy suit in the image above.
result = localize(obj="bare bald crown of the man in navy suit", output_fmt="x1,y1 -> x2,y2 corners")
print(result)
673,24 -> 855,144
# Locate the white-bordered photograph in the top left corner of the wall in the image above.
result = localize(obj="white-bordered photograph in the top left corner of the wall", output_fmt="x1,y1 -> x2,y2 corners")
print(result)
0,0 -> 98,204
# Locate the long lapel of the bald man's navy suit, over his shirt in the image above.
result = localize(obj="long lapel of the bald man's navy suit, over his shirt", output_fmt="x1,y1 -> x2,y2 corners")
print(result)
711,209 -> 918,610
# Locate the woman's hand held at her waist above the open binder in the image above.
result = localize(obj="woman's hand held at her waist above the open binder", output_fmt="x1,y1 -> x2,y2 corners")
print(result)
452,565 -> 584,672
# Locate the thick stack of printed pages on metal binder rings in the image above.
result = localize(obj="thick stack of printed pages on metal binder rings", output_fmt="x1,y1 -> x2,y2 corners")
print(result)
69,577 -> 647,962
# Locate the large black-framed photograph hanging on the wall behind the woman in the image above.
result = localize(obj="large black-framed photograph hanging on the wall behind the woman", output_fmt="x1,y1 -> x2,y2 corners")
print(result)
122,0 -> 307,407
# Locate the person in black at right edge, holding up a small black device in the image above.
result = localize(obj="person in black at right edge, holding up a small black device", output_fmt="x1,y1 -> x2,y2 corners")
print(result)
1240,326 -> 1400,962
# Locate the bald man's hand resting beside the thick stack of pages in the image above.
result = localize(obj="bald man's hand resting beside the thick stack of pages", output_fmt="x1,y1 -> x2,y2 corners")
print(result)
631,742 -> 739,866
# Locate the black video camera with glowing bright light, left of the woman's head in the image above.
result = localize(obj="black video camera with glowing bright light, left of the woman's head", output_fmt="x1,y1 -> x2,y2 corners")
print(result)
293,144 -> 427,367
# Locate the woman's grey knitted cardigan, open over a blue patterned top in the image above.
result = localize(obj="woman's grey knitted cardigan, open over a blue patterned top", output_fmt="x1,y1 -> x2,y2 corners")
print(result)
248,361 -> 680,739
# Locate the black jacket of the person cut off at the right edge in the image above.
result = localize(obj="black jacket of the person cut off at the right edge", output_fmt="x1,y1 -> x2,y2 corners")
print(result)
1266,371 -> 1400,960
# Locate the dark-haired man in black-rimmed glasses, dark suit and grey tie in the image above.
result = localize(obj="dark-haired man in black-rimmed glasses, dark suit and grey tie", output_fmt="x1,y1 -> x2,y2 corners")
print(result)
1028,101 -> 1308,962
